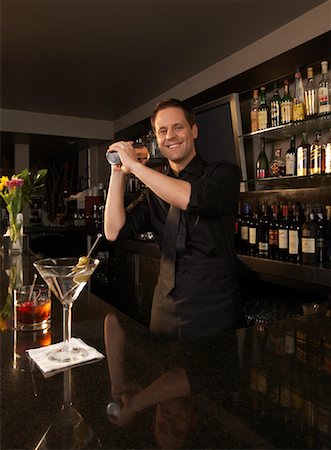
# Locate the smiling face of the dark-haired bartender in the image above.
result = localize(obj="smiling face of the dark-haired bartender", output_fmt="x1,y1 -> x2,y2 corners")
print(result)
154,107 -> 198,168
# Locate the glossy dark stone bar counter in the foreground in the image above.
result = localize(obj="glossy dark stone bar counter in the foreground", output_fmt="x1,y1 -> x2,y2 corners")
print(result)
0,251 -> 331,450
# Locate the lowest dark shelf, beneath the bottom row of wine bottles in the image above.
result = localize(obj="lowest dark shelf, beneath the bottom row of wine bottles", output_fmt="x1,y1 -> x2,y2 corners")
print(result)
238,255 -> 331,290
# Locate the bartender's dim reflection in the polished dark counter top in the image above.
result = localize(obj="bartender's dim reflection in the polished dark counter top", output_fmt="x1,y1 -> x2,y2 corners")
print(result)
104,313 -> 239,448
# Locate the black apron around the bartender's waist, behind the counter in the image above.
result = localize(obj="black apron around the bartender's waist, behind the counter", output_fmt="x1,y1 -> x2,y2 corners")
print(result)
150,255 -> 245,340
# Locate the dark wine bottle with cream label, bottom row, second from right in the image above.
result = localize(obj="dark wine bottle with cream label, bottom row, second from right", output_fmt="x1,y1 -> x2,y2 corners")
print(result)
301,204 -> 317,264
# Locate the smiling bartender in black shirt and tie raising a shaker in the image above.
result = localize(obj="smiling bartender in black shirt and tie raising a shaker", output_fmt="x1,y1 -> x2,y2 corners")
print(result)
104,99 -> 244,340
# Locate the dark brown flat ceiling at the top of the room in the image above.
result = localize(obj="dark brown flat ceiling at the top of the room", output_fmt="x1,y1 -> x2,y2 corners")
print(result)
1,0 -> 325,124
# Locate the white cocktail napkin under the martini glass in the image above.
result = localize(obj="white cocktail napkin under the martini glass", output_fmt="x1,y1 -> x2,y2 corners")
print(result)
26,338 -> 104,374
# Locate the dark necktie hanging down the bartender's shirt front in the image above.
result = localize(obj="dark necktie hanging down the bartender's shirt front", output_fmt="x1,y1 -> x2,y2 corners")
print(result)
160,205 -> 181,297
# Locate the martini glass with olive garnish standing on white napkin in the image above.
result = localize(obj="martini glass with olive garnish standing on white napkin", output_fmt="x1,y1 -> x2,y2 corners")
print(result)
33,257 -> 100,363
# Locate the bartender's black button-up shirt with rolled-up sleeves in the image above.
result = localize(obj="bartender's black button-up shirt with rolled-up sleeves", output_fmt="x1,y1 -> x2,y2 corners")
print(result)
119,155 -> 240,260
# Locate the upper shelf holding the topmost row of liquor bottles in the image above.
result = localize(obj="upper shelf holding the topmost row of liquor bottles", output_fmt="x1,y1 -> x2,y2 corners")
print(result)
239,114 -> 331,140
